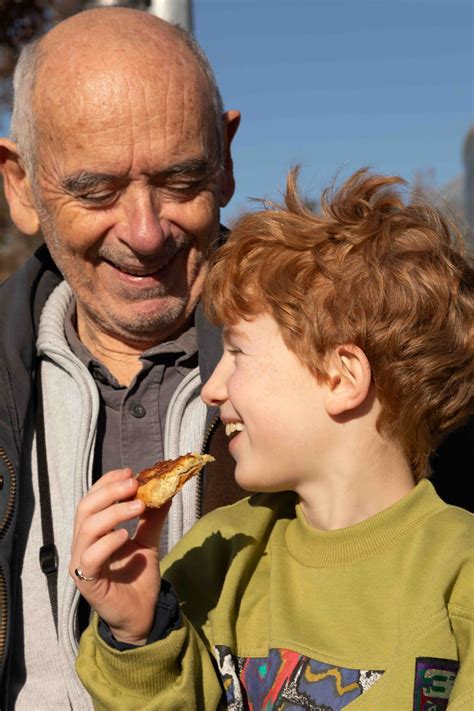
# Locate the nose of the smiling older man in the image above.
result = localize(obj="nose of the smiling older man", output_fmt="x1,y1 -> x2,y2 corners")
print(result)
121,190 -> 171,255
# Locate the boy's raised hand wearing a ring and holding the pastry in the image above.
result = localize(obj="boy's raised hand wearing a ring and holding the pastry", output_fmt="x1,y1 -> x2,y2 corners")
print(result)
69,469 -> 171,645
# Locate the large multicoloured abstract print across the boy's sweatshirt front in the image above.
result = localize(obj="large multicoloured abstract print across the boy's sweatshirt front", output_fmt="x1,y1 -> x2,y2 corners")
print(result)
215,646 -> 383,711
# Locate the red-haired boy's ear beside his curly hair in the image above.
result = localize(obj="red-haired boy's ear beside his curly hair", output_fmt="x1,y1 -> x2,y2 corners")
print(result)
325,343 -> 372,417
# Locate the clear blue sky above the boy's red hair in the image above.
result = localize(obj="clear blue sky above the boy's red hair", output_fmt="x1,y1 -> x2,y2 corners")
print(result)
194,0 -> 474,219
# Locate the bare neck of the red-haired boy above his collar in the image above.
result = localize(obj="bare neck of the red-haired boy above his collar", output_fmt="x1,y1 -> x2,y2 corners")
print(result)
297,438 -> 415,531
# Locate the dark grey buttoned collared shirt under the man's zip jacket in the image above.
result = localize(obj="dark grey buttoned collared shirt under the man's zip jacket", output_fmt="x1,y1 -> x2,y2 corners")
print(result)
65,301 -> 198,480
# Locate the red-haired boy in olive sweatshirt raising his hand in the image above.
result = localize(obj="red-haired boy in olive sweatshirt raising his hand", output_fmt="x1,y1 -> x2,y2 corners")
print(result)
71,170 -> 474,711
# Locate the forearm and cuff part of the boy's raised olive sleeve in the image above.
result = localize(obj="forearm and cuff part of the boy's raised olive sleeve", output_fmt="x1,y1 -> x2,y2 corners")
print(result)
77,615 -> 225,711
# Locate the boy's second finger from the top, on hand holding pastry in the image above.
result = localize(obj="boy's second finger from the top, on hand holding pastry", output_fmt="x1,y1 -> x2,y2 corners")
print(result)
71,499 -> 145,560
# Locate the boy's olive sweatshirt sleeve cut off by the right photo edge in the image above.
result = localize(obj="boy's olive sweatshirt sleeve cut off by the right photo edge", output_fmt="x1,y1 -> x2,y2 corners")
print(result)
448,560 -> 474,711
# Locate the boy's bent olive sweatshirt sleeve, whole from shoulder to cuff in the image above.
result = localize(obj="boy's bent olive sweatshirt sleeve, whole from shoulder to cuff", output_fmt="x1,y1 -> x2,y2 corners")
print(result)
77,501 -> 262,711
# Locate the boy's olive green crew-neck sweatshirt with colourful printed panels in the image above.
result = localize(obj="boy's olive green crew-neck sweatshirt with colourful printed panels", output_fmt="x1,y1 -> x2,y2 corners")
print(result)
77,481 -> 474,711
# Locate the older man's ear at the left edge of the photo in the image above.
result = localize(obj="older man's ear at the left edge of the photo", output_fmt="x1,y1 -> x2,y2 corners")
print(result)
0,138 -> 39,235
